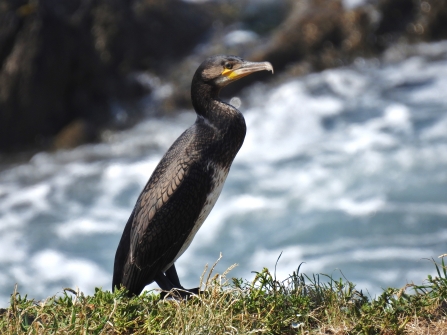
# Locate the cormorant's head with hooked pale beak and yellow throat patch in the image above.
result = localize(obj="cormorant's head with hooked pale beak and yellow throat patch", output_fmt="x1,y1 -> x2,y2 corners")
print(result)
194,55 -> 273,89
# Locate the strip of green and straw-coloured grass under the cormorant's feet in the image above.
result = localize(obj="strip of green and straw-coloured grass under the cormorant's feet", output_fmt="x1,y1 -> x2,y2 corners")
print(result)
0,255 -> 447,335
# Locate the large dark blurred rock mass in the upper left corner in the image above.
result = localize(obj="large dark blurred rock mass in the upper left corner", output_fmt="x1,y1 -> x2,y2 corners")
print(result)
0,0 -> 212,151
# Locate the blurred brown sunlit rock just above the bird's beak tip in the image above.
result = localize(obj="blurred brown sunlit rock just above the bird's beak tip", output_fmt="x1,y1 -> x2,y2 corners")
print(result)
248,0 -> 375,71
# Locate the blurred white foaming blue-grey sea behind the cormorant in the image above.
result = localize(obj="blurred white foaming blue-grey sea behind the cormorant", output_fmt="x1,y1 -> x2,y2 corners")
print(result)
0,43 -> 447,306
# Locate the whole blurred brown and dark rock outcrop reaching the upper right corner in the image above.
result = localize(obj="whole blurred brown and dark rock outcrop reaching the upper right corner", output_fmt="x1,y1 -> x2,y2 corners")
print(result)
251,0 -> 447,74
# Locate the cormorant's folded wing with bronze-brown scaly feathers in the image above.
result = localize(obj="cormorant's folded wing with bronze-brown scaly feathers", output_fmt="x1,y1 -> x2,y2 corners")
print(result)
123,127 -> 212,288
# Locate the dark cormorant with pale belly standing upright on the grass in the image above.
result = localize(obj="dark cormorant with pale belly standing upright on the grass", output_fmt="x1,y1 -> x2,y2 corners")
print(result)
112,55 -> 273,296
